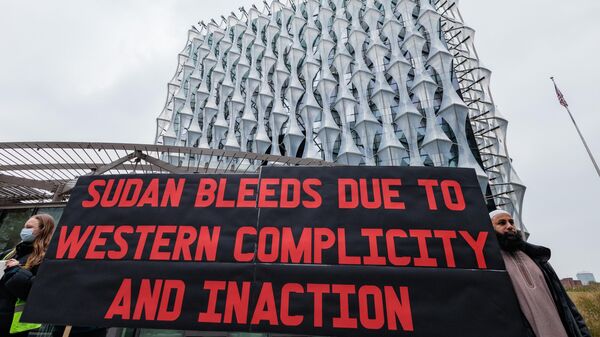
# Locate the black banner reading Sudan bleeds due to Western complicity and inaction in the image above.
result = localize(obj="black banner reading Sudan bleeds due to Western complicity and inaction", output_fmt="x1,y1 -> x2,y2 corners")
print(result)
24,167 -> 522,337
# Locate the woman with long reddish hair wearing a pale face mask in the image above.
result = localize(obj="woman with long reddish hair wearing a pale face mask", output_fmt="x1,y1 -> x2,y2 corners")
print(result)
0,214 -> 54,337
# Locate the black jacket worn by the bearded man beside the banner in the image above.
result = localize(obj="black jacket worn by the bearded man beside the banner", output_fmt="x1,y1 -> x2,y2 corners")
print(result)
523,243 -> 591,337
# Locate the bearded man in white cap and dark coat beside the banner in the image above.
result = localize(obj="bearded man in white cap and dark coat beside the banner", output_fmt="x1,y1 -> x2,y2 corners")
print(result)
490,210 -> 591,337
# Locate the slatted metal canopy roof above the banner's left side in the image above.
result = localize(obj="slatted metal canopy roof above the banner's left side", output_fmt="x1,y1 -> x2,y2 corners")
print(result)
0,142 -> 334,205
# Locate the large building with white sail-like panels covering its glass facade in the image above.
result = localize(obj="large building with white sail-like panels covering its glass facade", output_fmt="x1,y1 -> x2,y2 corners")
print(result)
156,0 -> 525,224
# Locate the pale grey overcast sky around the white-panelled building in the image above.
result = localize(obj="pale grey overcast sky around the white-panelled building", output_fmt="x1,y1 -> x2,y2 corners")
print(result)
0,0 -> 600,280
